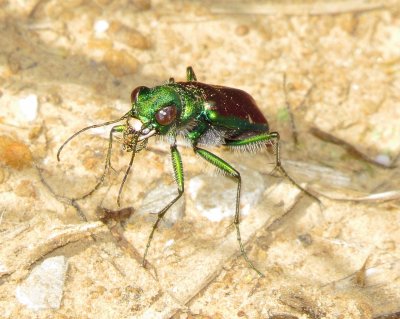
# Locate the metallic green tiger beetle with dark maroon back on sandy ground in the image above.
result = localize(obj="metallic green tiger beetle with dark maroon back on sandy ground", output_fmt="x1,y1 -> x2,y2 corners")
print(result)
57,67 -> 320,276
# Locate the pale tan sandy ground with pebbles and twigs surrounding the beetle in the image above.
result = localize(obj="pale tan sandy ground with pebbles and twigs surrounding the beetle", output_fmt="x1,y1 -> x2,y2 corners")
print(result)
0,0 -> 400,319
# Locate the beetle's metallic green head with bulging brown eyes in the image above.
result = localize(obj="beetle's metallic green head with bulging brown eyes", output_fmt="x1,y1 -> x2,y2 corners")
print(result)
131,85 -> 182,139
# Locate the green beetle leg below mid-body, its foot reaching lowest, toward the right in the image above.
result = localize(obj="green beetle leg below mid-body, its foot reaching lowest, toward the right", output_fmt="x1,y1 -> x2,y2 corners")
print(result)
194,147 -> 264,277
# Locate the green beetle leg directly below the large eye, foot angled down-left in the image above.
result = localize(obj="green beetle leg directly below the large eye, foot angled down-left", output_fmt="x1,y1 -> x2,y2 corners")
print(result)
142,144 -> 185,267
